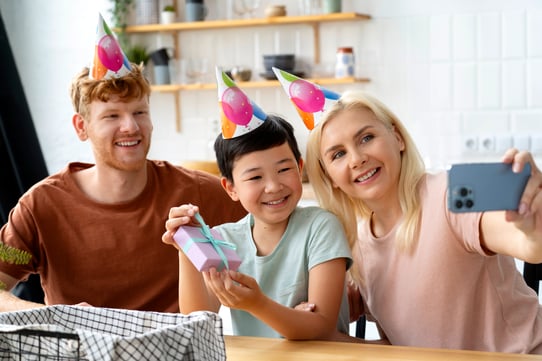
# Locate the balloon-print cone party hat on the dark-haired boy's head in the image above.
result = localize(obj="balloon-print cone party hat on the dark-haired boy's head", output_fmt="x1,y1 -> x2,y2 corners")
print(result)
216,68 -> 267,139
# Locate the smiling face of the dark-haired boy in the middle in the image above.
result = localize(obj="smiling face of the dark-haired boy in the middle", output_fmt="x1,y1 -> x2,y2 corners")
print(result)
222,142 -> 303,226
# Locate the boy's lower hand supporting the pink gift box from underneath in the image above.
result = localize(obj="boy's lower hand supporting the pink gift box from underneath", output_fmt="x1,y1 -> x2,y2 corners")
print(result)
203,268 -> 264,312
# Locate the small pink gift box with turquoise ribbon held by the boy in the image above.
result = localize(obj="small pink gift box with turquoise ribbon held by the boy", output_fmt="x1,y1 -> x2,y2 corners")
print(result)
173,213 -> 241,271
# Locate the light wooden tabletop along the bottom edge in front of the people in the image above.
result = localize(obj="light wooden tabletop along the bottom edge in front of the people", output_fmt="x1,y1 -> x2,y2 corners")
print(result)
225,336 -> 542,361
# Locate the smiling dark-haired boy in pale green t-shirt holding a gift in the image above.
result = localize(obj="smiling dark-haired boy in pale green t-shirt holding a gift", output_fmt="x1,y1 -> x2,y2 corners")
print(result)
163,69 -> 351,340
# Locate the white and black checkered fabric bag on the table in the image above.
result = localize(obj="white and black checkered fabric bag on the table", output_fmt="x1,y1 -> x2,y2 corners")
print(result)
0,305 -> 226,361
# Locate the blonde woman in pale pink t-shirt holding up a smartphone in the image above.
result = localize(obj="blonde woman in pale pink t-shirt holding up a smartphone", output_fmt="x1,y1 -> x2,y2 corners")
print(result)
306,92 -> 542,353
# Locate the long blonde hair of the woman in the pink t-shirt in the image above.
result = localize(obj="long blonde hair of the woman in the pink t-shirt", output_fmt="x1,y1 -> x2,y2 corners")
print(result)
306,91 -> 425,251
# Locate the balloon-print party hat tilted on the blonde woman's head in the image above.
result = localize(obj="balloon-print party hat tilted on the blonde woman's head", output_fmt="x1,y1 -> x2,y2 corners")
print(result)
273,67 -> 340,130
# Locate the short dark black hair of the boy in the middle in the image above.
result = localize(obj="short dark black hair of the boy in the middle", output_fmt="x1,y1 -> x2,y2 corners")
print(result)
215,115 -> 301,182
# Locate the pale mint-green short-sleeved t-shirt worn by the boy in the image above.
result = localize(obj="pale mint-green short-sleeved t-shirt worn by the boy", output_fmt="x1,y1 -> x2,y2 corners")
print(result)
216,207 -> 352,338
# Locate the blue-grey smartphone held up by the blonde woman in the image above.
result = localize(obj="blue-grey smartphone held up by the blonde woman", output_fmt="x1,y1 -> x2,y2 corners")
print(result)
448,163 -> 531,213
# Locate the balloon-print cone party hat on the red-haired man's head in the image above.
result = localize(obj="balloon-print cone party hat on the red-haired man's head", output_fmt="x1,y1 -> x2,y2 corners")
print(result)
89,14 -> 132,80
